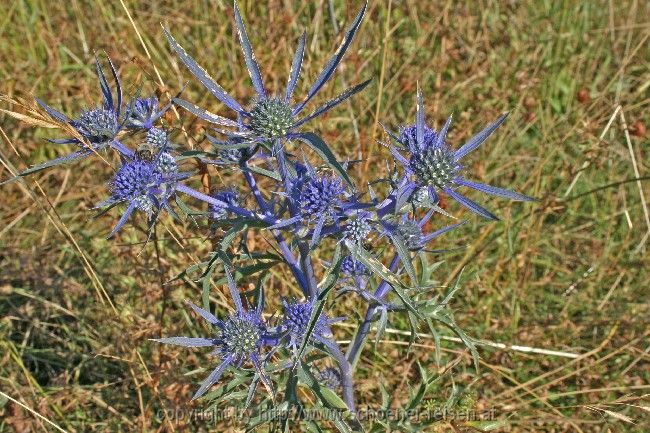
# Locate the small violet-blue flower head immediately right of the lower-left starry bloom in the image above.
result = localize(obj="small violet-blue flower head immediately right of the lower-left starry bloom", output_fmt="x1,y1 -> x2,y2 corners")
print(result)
281,299 -> 336,350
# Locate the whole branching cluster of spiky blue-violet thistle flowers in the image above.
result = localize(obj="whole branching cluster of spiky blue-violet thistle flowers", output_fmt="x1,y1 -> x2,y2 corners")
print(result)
8,2 -> 531,411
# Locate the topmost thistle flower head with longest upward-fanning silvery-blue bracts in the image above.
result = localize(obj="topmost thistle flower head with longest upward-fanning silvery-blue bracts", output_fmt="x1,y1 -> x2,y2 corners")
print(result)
165,1 -> 371,143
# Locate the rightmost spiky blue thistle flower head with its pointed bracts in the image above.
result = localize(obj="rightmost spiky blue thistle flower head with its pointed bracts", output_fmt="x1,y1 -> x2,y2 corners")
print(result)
387,86 -> 535,220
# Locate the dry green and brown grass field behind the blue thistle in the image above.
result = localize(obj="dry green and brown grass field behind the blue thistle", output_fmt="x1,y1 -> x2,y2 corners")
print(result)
0,0 -> 650,433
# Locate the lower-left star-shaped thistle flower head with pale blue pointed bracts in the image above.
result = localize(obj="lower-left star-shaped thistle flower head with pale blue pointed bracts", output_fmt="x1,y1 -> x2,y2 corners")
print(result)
153,267 -> 274,400
